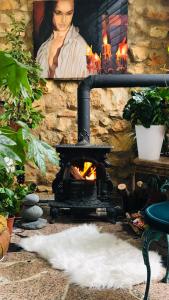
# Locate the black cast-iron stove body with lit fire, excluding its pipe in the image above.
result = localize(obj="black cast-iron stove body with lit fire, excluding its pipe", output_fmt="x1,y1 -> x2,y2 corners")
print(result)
53,144 -> 119,208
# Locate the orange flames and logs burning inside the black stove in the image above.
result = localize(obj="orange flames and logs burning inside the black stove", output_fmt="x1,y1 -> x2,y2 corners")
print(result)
73,162 -> 96,180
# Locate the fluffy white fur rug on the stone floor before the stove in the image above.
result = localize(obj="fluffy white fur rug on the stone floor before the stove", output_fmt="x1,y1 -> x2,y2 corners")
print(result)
20,224 -> 164,288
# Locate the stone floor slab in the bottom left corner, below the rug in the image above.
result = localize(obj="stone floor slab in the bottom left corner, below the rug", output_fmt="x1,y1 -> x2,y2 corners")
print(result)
0,270 -> 69,300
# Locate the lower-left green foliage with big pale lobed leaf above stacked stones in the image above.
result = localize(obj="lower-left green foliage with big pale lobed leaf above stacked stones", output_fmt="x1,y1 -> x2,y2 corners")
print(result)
0,122 -> 58,215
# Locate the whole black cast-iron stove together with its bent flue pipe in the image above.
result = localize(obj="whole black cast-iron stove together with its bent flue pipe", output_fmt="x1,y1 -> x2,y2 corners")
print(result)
50,74 -> 169,221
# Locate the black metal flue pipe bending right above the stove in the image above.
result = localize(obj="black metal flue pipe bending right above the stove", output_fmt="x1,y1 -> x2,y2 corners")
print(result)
78,74 -> 169,145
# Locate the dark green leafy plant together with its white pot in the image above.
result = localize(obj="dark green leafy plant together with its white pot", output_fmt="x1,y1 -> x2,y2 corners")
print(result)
123,87 -> 169,160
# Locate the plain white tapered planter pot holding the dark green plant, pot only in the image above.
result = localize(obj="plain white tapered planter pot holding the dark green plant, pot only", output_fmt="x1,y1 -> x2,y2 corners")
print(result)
135,125 -> 165,160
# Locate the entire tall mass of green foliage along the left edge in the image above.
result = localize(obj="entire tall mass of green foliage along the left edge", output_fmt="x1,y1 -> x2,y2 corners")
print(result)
0,19 -> 58,215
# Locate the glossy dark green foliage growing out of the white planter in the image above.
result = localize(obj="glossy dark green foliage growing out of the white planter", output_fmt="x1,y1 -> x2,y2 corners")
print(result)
123,87 -> 169,128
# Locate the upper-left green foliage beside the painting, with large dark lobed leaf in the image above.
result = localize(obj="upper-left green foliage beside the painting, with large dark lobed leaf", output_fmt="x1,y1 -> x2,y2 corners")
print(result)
0,16 -> 46,128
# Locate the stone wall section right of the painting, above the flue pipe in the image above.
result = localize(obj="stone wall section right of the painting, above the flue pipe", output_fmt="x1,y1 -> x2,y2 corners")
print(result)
128,0 -> 169,73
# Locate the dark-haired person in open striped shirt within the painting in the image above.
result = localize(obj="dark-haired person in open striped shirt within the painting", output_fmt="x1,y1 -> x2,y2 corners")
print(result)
36,0 -> 88,78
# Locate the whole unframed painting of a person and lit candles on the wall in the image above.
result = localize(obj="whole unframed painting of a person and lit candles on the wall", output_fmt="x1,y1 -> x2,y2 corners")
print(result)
33,0 -> 128,80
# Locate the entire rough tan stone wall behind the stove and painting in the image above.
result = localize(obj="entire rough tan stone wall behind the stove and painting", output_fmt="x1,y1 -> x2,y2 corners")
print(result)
0,0 -> 169,191
